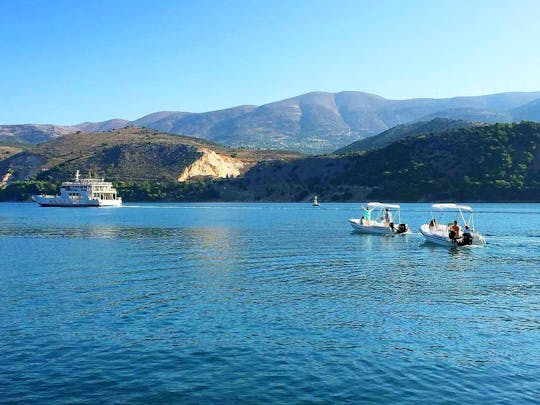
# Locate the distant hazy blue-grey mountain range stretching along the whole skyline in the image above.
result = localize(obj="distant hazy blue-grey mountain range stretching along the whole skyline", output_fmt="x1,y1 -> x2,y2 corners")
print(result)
0,91 -> 540,154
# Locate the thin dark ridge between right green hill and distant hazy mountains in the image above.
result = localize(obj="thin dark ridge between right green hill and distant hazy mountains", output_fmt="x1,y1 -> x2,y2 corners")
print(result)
334,118 -> 482,154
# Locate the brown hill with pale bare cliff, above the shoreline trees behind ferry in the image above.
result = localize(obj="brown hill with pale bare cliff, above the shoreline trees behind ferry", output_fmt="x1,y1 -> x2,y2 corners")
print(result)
0,127 -> 299,187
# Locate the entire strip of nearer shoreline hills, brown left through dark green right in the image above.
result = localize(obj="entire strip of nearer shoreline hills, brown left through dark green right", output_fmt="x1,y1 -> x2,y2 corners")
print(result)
0,122 -> 540,204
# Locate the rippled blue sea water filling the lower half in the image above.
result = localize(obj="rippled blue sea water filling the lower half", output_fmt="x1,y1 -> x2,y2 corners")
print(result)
0,203 -> 540,404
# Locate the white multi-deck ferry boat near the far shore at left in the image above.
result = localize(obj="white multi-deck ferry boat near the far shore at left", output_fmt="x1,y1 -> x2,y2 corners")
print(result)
32,170 -> 122,207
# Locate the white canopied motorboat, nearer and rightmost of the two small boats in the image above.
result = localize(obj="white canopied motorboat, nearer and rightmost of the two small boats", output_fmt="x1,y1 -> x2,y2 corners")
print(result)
420,203 -> 486,246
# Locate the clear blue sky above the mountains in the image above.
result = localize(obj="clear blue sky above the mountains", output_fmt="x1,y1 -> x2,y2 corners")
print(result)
0,0 -> 540,124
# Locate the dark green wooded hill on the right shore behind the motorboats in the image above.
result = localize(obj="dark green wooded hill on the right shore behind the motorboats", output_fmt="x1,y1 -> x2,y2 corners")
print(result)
213,122 -> 540,202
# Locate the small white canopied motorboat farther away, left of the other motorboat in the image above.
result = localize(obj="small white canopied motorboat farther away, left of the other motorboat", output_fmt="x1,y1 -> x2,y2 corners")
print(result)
349,202 -> 409,235
